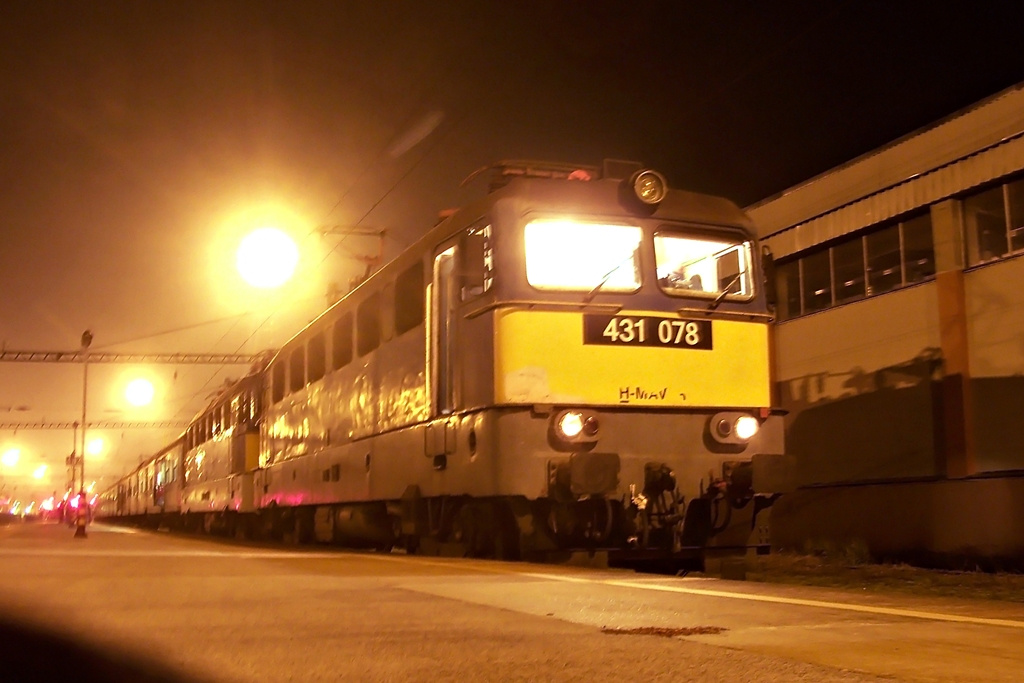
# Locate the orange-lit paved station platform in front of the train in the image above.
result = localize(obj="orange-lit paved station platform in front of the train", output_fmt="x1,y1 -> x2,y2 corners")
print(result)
0,523 -> 1024,683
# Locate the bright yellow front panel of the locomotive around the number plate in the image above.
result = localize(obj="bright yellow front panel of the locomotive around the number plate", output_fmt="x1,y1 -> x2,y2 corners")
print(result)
495,309 -> 770,408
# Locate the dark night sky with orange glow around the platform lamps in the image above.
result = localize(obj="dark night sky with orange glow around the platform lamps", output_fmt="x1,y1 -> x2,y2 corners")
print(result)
0,0 -> 1024,496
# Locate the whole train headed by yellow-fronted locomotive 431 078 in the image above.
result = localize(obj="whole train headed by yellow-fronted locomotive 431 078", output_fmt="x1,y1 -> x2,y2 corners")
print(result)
99,162 -> 787,566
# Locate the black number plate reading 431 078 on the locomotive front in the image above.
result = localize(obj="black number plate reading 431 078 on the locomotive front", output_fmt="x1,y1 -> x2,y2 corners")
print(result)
583,313 -> 712,349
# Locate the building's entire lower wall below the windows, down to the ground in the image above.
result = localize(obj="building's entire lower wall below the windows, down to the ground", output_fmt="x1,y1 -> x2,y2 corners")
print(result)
771,257 -> 1024,570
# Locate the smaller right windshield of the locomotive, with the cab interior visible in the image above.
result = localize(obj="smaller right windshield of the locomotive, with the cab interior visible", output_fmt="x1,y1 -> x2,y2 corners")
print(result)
654,232 -> 753,299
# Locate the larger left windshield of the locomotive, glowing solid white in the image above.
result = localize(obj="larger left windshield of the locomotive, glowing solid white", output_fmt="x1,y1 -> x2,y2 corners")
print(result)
524,220 -> 643,292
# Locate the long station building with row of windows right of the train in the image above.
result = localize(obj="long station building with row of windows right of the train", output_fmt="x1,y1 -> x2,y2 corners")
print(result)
748,84 -> 1024,566
